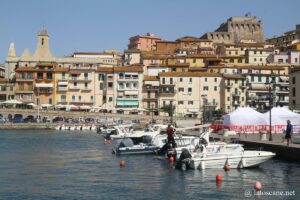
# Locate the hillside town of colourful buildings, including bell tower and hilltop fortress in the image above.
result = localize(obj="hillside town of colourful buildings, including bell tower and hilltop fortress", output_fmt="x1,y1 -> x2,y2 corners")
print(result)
0,15 -> 300,121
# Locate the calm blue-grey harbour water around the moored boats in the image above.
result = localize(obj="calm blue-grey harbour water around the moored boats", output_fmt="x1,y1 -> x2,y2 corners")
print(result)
0,130 -> 300,199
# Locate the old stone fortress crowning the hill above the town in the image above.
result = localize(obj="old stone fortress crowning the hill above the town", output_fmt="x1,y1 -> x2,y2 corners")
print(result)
201,14 -> 265,44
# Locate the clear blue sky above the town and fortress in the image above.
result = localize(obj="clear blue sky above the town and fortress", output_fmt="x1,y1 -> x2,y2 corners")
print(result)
0,0 -> 300,63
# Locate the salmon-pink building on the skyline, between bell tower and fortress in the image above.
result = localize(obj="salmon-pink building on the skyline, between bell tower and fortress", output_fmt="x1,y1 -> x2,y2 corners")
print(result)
128,33 -> 161,51
